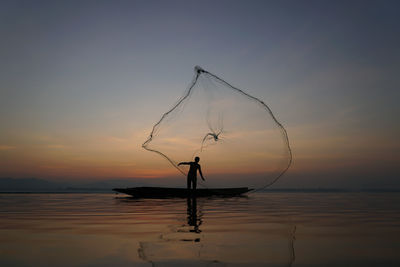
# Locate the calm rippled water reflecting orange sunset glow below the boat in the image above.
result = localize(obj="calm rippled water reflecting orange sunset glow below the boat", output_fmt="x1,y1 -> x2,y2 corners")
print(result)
0,193 -> 400,266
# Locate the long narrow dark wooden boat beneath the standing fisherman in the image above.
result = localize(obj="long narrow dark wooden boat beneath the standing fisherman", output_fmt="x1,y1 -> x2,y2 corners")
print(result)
113,187 -> 251,198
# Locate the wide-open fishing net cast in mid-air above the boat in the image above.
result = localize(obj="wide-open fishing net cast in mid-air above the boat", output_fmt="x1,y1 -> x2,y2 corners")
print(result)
143,67 -> 292,188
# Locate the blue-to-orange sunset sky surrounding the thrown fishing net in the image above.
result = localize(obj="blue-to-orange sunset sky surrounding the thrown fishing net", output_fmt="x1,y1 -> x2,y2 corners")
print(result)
0,1 -> 400,188
